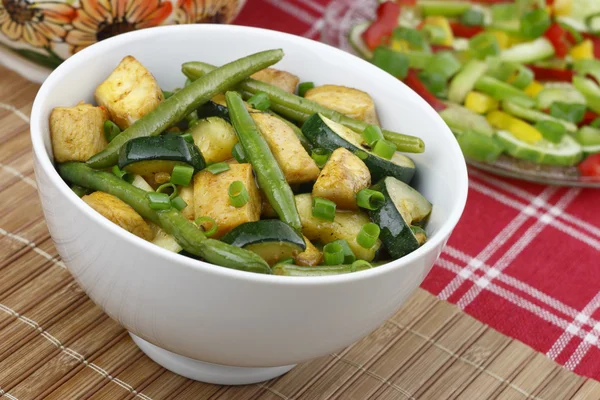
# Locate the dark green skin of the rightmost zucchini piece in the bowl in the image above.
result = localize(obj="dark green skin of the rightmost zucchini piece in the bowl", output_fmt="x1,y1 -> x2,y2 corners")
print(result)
368,178 -> 419,259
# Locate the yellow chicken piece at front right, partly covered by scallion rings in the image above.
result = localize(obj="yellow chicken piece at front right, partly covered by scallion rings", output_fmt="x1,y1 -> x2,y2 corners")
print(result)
295,193 -> 381,261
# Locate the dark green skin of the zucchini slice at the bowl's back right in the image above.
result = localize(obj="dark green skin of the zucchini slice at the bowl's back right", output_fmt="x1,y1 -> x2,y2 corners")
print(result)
302,114 -> 415,183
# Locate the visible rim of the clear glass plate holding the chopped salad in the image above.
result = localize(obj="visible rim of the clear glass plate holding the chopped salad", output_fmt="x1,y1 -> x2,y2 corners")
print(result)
321,0 -> 600,188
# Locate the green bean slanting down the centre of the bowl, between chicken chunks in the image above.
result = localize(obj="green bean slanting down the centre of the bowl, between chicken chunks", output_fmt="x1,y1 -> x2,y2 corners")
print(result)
225,92 -> 302,231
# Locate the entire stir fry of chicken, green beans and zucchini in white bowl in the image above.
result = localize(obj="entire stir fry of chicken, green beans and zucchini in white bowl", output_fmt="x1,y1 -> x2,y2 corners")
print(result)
50,50 -> 432,276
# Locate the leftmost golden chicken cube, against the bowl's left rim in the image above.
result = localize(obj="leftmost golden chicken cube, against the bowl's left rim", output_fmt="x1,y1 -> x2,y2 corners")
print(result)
50,103 -> 108,162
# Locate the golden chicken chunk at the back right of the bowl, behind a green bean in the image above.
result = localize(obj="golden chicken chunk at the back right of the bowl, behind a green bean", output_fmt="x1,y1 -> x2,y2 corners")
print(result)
304,85 -> 379,125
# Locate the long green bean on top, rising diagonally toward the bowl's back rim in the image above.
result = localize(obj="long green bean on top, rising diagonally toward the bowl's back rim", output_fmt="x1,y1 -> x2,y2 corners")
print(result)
87,49 -> 283,168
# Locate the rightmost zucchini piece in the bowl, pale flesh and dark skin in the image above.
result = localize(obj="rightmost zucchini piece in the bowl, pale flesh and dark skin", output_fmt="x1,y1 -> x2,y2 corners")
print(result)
369,177 -> 432,258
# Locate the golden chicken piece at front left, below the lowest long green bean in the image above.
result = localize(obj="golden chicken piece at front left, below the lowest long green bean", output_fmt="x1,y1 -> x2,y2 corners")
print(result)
81,192 -> 154,240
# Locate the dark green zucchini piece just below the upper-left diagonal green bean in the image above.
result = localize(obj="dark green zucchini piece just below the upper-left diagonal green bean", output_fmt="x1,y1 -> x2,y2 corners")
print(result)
119,135 -> 206,171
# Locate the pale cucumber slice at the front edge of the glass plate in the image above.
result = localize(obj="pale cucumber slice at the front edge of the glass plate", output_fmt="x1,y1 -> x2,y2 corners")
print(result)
496,130 -> 583,166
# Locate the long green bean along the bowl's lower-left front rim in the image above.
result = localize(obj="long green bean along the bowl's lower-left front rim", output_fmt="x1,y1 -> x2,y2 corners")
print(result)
57,162 -> 271,274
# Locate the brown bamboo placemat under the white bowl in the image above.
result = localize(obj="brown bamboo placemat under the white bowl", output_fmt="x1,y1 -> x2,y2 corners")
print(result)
0,67 -> 600,400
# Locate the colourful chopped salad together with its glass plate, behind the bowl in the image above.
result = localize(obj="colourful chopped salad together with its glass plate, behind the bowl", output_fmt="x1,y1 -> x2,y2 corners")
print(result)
322,0 -> 600,188
